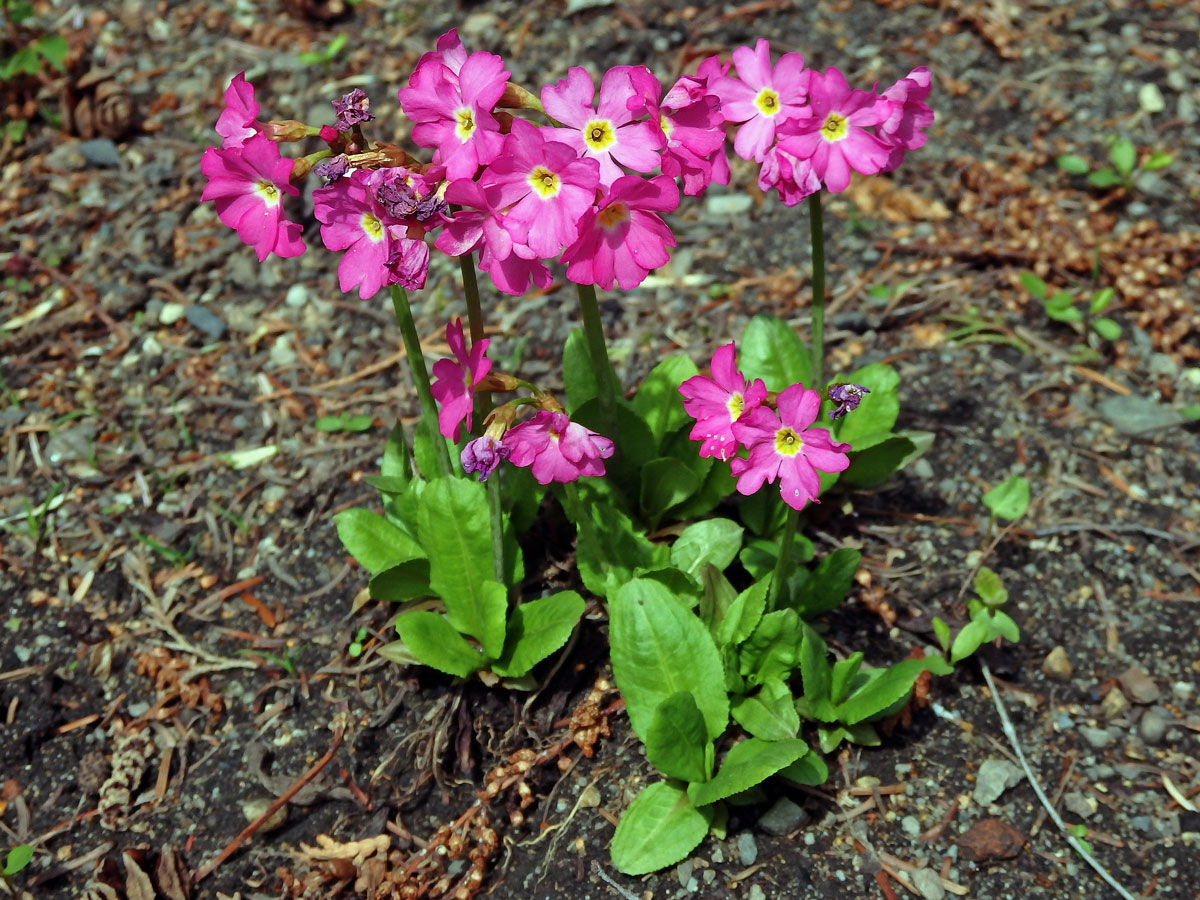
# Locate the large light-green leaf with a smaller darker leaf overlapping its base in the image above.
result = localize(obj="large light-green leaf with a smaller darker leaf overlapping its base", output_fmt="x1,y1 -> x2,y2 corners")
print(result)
608,578 -> 730,742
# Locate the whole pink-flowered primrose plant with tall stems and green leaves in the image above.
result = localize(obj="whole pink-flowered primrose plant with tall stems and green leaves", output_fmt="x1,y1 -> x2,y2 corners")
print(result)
202,31 -> 1015,874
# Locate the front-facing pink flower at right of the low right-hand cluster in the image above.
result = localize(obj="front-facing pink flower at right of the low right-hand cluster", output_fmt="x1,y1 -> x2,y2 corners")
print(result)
730,384 -> 851,509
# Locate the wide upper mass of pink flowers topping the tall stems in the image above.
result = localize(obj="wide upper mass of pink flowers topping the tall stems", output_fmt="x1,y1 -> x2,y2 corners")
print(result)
202,31 -> 934,298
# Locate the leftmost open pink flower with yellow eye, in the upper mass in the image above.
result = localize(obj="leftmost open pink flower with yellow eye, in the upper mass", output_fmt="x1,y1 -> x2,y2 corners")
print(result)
200,134 -> 305,262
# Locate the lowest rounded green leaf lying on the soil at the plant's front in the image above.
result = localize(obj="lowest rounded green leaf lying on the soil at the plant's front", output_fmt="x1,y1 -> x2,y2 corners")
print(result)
611,781 -> 713,875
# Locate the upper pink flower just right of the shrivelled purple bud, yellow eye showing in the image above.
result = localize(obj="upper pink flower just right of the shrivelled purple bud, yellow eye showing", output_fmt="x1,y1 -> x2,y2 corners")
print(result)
398,44 -> 509,179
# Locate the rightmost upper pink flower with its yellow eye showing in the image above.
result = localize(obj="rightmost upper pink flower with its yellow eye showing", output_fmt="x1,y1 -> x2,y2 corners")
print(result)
779,66 -> 892,193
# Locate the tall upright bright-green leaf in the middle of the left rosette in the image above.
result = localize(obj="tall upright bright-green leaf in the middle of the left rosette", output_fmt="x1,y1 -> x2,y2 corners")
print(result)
418,475 -> 508,656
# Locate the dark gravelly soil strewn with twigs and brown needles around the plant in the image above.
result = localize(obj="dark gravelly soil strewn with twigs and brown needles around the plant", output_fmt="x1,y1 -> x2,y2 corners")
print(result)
0,0 -> 1200,900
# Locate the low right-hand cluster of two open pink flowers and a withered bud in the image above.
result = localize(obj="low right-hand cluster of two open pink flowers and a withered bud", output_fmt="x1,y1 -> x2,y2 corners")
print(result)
679,343 -> 869,509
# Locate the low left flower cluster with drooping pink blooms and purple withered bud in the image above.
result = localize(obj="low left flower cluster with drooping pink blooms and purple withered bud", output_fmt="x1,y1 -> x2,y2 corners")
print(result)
432,319 -> 613,485
